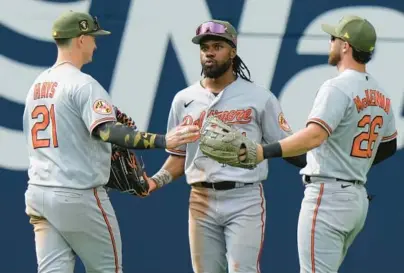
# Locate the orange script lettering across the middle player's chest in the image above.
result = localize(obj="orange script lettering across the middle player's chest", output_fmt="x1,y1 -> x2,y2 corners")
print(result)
183,108 -> 252,127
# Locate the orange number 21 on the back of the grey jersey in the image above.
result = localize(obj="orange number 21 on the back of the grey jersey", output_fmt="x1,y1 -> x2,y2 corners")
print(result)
31,104 -> 59,149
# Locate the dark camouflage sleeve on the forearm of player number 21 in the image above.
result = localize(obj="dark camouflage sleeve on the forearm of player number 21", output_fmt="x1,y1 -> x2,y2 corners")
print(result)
93,121 -> 166,149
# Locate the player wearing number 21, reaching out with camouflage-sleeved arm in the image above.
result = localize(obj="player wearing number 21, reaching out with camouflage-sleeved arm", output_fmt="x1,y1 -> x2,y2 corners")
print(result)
23,11 -> 199,273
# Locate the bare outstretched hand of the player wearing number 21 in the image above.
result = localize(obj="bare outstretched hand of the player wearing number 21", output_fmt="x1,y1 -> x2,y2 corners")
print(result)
166,125 -> 200,149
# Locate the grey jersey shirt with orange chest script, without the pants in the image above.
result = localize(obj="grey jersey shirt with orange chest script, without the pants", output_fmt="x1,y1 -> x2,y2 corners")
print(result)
167,78 -> 291,184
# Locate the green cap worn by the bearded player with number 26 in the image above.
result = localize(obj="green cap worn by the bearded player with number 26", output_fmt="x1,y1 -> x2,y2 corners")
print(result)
321,15 -> 376,52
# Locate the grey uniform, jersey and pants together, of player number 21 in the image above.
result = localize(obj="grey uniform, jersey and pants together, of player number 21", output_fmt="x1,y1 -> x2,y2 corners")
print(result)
23,63 -> 122,272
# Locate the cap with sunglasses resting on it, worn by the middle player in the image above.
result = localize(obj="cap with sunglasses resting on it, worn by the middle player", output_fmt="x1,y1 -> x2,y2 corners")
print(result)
192,20 -> 237,46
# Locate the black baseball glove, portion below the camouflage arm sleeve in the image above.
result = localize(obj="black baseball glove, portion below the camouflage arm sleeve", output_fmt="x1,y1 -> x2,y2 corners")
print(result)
105,144 -> 149,197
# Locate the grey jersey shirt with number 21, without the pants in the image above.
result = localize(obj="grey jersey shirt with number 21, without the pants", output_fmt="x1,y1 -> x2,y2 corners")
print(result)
23,64 -> 116,189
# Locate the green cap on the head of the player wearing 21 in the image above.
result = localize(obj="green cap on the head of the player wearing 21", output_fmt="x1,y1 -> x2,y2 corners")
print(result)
52,11 -> 111,39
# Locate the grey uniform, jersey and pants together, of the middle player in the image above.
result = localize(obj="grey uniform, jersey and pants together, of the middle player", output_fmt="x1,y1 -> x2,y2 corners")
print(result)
167,78 -> 292,273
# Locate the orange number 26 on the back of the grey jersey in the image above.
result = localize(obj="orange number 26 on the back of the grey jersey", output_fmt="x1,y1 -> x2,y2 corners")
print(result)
351,115 -> 383,158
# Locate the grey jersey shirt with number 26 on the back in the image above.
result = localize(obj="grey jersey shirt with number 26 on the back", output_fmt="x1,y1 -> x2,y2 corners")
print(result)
301,70 -> 397,183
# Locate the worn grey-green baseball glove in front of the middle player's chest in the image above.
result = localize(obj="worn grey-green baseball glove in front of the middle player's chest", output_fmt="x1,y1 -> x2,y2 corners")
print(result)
199,116 -> 257,169
